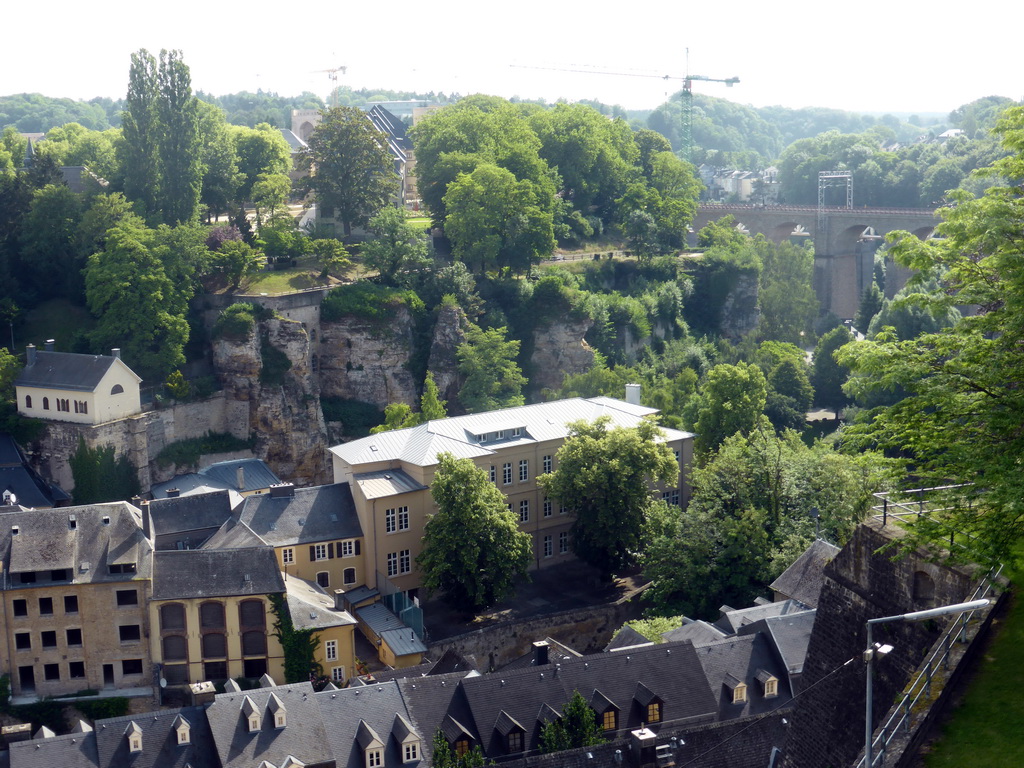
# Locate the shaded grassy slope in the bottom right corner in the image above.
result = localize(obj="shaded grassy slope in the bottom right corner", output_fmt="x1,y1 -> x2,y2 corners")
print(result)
924,573 -> 1024,768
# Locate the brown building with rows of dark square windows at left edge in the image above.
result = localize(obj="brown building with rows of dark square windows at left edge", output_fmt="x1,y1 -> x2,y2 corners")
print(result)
0,502 -> 153,696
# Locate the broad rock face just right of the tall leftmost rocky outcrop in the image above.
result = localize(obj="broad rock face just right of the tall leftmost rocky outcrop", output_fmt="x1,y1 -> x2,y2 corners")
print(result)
319,307 -> 418,409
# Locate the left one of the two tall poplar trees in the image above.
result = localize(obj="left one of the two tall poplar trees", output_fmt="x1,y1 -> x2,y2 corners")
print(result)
119,48 -> 160,219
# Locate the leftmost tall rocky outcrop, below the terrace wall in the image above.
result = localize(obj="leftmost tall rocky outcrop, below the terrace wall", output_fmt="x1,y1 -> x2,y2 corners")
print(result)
213,317 -> 331,485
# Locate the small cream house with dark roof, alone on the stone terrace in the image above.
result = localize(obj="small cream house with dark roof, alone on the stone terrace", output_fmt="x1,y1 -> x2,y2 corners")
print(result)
14,341 -> 142,424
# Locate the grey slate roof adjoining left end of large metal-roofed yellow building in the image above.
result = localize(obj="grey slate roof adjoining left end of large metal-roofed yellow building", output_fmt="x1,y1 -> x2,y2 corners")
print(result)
239,482 -> 362,547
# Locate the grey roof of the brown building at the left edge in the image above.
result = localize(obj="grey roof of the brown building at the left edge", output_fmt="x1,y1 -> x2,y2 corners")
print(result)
0,502 -> 153,589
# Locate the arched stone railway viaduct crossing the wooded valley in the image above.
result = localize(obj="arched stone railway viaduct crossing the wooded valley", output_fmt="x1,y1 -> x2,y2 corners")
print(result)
693,204 -> 939,317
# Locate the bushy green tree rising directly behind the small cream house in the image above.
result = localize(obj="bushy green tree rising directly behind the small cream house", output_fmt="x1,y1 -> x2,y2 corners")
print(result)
85,223 -> 188,381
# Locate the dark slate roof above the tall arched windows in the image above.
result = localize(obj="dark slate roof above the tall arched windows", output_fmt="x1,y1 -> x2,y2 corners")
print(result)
153,547 -> 285,600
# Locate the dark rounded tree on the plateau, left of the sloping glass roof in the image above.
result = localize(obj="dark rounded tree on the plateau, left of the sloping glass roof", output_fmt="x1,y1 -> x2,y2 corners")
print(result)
301,106 -> 398,237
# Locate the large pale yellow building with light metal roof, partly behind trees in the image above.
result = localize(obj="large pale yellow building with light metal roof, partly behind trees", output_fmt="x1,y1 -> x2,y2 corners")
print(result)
331,392 -> 693,597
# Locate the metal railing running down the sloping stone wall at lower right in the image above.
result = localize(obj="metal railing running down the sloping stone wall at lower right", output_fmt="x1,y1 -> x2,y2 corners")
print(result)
856,565 -> 1002,768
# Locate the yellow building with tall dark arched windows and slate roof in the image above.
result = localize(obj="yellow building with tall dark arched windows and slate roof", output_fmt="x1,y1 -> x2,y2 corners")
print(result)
148,547 -> 285,685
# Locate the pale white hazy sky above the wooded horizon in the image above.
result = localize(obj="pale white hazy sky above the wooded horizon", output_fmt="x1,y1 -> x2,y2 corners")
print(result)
0,0 -> 1024,113
